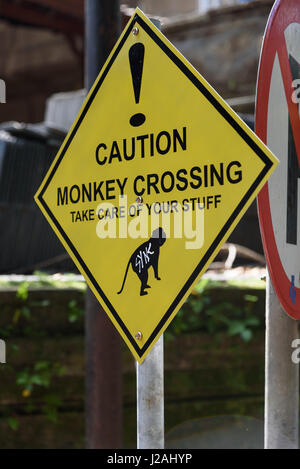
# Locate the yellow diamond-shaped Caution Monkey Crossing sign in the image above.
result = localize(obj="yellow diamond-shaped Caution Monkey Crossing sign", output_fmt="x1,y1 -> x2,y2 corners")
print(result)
35,9 -> 277,363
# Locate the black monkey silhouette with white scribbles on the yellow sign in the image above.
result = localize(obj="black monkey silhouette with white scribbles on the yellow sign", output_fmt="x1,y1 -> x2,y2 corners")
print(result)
118,228 -> 166,296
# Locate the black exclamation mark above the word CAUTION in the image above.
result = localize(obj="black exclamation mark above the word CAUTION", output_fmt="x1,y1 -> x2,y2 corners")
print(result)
129,42 -> 146,127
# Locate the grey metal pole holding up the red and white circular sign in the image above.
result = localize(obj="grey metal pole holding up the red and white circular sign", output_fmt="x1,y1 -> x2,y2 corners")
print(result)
265,274 -> 299,449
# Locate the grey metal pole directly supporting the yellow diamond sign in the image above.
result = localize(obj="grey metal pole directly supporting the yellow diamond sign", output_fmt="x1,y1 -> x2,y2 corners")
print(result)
136,335 -> 164,449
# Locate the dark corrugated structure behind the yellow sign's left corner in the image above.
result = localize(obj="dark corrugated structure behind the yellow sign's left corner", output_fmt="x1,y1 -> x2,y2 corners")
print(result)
0,124 -> 75,273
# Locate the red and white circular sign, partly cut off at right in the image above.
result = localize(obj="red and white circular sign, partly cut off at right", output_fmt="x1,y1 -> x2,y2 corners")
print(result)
256,0 -> 300,319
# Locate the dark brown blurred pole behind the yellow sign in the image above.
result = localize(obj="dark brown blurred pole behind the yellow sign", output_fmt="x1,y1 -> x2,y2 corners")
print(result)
85,0 -> 122,449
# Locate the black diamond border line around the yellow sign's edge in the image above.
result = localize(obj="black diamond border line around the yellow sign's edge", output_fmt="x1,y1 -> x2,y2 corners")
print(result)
38,13 -> 273,357
